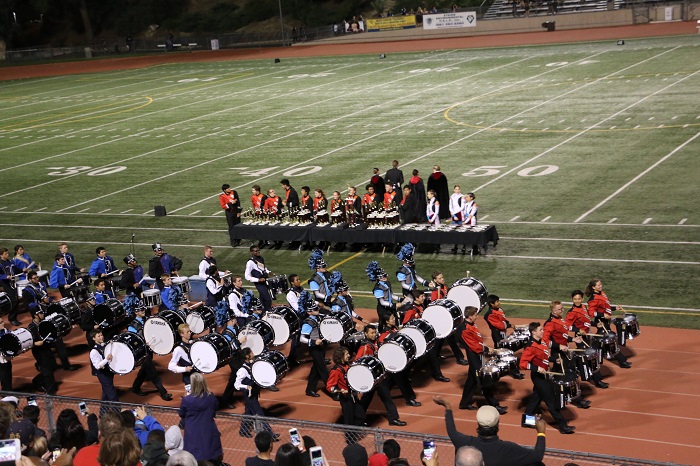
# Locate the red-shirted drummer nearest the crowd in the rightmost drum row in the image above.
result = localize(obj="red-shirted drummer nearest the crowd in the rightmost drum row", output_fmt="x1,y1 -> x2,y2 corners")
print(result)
520,322 -> 575,434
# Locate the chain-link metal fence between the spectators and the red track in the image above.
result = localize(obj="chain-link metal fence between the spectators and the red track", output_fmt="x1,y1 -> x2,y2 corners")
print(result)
2,387 -> 679,466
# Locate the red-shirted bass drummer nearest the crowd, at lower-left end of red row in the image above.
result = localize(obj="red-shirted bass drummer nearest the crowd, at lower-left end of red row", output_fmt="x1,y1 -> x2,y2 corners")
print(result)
326,346 -> 365,443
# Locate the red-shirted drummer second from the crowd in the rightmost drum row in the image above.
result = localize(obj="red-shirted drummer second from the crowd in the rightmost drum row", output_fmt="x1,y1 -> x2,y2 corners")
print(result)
542,301 -> 591,409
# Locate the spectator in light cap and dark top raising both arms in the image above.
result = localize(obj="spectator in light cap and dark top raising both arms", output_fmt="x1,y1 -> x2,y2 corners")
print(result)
433,396 -> 547,466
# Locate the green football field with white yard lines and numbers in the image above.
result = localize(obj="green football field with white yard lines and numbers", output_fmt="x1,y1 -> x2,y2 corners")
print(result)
0,36 -> 700,328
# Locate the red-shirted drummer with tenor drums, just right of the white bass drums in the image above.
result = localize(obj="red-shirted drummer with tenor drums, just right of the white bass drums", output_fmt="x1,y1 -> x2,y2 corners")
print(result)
459,306 -> 508,414
